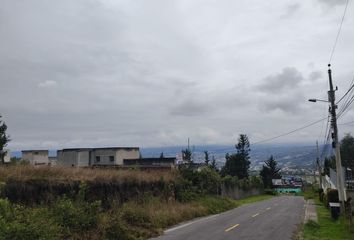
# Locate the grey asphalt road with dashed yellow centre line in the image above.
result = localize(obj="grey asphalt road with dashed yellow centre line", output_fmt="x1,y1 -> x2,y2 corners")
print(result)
154,196 -> 305,240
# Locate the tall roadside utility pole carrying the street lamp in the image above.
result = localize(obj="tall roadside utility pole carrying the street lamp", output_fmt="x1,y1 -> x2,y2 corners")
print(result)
328,64 -> 347,211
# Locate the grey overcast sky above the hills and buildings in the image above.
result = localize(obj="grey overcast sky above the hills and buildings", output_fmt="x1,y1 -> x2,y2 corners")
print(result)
0,0 -> 354,150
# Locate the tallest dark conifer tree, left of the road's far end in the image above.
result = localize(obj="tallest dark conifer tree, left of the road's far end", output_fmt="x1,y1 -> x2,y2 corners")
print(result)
222,134 -> 251,179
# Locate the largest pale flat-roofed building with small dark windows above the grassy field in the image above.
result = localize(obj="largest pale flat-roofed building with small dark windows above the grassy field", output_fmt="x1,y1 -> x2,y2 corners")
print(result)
57,147 -> 140,167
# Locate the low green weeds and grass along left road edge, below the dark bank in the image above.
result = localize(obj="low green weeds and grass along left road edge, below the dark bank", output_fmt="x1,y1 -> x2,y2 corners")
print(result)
0,189 -> 271,240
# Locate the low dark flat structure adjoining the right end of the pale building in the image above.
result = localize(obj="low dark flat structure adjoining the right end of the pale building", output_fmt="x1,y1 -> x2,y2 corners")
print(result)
123,157 -> 177,168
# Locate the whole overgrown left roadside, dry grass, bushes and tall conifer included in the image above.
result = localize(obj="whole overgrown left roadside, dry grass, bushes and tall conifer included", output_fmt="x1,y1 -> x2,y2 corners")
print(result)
0,132 -> 280,240
